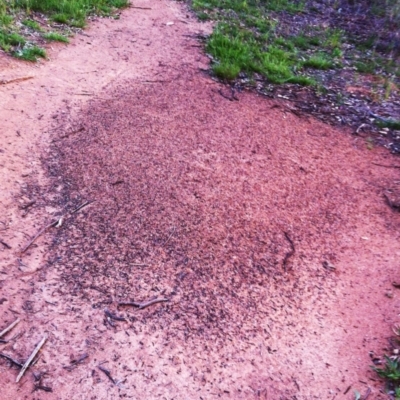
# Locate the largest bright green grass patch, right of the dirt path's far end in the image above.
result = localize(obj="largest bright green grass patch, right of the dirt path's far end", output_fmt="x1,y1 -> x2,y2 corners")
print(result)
192,0 -> 343,86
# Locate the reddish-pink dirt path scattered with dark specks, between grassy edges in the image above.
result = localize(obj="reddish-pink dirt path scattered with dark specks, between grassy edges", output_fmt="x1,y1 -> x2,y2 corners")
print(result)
0,1 -> 400,400
